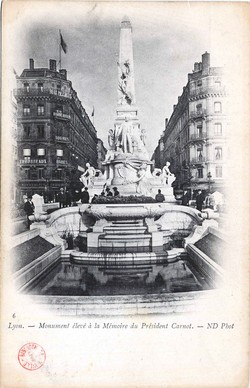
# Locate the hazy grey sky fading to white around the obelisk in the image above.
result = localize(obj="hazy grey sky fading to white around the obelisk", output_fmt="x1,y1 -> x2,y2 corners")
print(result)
8,1 -> 238,154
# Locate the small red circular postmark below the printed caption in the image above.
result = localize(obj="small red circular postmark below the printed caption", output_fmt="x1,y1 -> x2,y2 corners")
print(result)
18,342 -> 46,370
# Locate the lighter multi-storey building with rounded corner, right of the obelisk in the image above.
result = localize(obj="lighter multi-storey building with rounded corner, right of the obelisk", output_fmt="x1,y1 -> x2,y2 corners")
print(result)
153,52 -> 229,192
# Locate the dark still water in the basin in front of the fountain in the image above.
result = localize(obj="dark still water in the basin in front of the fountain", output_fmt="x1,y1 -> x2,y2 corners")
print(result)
29,259 -> 207,296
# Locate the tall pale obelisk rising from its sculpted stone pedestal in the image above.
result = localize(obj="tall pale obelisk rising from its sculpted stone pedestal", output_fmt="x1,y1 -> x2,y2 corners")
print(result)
95,17 -> 174,200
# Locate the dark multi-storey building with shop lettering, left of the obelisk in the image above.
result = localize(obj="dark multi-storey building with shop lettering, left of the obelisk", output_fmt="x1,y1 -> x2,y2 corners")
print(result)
14,59 -> 98,201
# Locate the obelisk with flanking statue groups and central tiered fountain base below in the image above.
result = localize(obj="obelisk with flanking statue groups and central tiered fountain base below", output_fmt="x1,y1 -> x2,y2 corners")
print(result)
72,19 -> 183,261
